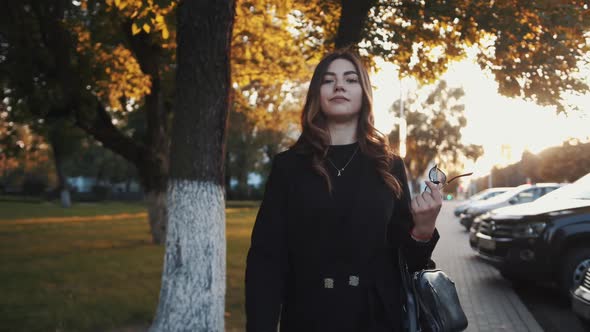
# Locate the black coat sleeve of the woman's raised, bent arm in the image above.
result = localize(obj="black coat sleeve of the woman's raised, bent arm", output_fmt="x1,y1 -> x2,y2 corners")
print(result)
389,156 -> 440,272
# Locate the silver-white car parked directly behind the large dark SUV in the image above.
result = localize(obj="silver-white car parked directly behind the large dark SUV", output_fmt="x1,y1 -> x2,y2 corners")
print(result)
459,183 -> 562,230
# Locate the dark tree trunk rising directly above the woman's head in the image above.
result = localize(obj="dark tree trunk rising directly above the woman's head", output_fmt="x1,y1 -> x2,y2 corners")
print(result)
336,0 -> 377,49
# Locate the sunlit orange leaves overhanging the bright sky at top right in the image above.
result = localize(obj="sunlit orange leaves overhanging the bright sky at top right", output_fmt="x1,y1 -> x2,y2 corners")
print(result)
362,0 -> 590,111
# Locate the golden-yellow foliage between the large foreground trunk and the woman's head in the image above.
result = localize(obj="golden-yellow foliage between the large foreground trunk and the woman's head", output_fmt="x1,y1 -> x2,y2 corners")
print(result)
231,0 -> 340,131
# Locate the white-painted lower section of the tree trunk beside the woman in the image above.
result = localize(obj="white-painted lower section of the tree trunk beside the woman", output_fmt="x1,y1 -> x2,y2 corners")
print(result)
149,179 -> 226,332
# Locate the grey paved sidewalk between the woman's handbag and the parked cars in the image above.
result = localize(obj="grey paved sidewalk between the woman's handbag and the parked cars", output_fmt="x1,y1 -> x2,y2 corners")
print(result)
433,201 -> 543,332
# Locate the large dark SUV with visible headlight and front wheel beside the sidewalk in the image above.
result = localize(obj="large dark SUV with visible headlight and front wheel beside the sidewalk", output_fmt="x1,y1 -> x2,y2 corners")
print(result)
469,174 -> 590,296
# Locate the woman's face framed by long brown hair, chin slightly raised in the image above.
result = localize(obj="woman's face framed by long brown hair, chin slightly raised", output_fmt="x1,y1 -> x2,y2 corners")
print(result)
320,59 -> 363,121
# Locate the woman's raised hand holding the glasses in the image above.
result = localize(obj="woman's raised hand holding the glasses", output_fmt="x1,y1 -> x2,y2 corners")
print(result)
411,181 -> 442,238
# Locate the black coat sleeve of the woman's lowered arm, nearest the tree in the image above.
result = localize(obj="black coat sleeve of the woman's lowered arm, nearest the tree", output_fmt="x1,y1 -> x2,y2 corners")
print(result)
245,154 -> 288,332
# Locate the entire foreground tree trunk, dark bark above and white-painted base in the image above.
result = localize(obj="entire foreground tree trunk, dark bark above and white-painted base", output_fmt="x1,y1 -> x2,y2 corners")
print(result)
150,0 -> 235,332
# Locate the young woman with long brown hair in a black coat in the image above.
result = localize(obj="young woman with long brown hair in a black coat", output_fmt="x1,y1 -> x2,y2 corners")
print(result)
246,51 -> 442,332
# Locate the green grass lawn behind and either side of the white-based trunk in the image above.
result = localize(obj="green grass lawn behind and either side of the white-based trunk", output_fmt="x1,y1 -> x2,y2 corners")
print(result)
0,202 -> 258,332
